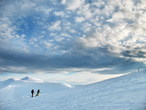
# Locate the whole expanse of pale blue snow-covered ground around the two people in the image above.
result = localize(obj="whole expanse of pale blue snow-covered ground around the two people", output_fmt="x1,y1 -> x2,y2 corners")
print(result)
0,72 -> 146,110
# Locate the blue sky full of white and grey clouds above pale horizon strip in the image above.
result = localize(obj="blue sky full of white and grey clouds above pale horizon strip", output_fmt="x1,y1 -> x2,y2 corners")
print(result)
0,0 -> 146,83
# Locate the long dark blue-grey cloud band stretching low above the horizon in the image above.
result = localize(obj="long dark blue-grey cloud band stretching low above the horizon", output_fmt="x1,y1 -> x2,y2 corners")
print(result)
0,43 -> 144,74
